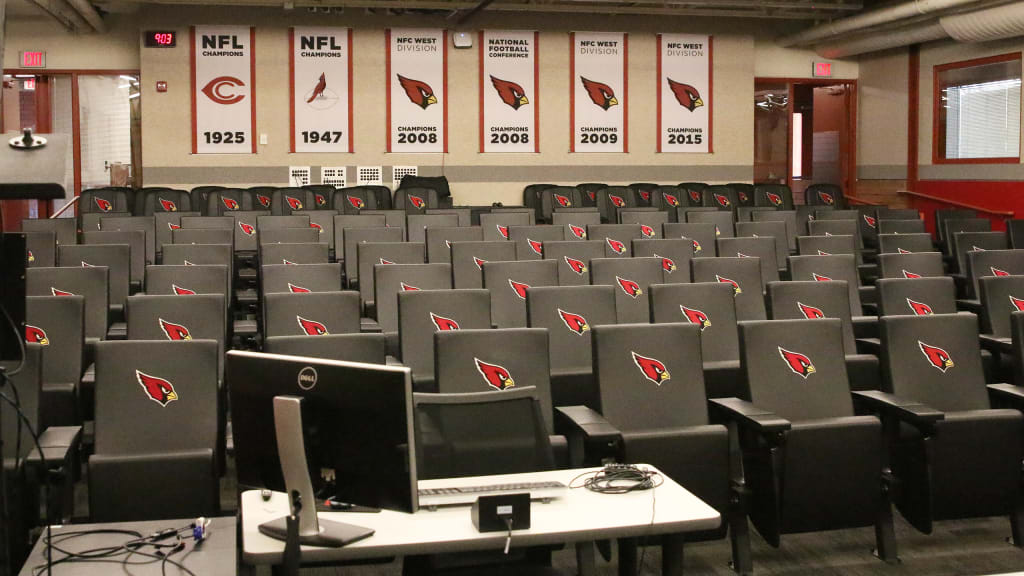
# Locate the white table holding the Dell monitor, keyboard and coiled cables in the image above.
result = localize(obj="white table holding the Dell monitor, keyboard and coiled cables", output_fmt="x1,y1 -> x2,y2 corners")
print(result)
241,466 -> 722,574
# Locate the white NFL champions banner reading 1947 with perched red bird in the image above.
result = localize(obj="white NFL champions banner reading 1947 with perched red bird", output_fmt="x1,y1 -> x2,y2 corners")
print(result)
288,28 -> 352,152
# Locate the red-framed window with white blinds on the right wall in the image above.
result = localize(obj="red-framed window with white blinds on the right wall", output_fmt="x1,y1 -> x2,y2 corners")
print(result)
932,52 -> 1021,164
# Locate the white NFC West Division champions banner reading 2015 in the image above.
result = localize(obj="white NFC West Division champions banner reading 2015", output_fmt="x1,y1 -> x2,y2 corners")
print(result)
657,34 -> 712,153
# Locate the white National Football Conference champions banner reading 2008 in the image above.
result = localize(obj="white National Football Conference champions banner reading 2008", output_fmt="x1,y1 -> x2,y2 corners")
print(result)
480,30 -> 541,152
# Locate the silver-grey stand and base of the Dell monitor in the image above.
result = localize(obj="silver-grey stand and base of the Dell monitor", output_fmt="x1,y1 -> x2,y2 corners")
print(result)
259,396 -> 374,548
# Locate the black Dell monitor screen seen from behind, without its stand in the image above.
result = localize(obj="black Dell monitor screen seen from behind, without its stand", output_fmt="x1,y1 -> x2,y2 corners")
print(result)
225,351 -> 417,512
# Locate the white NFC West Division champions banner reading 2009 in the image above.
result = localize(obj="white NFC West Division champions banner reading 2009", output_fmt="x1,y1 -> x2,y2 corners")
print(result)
569,32 -> 629,152
